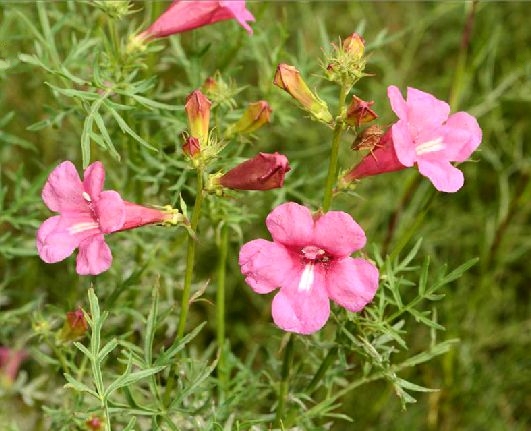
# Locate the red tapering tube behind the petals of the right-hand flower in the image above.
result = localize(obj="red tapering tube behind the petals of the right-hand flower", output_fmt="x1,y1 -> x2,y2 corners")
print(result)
341,129 -> 406,184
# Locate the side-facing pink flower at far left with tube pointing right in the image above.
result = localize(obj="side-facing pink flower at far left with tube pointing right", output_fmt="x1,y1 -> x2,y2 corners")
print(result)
37,161 -> 181,275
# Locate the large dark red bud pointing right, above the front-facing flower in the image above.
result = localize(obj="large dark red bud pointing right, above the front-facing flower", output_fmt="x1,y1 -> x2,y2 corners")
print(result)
218,153 -> 290,190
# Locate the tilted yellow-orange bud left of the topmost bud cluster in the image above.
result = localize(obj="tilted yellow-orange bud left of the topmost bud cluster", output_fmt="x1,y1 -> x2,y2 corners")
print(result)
273,64 -> 332,123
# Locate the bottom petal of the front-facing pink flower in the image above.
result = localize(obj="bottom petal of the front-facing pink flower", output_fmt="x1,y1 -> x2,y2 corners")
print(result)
272,267 -> 330,334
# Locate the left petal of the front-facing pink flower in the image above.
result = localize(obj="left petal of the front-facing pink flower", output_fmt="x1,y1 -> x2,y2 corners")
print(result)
239,239 -> 302,293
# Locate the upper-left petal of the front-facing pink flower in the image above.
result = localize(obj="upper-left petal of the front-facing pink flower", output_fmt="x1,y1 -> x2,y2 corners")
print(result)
266,202 -> 314,248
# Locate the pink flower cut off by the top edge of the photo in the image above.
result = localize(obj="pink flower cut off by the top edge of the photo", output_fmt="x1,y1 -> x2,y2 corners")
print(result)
140,0 -> 254,38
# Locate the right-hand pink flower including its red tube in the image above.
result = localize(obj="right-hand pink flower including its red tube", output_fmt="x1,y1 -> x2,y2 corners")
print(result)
344,86 -> 481,192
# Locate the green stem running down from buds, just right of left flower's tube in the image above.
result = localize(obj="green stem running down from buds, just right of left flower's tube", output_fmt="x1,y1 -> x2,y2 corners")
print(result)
164,169 -> 203,406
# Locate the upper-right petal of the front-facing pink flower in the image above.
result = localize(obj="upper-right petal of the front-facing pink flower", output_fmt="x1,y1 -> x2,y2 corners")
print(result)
313,211 -> 367,257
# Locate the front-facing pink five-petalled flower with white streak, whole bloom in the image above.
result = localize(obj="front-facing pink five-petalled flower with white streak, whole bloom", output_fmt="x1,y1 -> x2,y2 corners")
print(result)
239,202 -> 378,334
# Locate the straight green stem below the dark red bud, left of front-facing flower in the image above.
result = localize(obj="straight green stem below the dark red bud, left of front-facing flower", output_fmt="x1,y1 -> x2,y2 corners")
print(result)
216,224 -> 229,400
